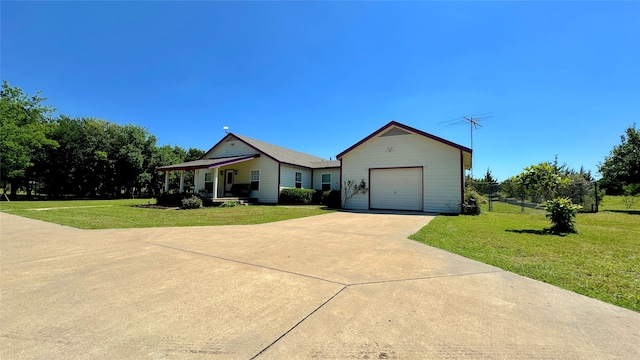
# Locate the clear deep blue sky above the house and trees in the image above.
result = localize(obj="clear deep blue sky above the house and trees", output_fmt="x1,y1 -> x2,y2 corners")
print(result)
0,1 -> 640,180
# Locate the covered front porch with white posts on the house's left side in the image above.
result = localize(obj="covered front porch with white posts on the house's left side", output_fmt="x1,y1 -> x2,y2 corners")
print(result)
156,154 -> 260,203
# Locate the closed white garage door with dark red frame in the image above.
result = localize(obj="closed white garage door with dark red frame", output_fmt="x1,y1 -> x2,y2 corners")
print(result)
369,168 -> 422,211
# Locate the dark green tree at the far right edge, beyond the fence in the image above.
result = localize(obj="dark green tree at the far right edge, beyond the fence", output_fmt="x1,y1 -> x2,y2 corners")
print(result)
598,124 -> 640,195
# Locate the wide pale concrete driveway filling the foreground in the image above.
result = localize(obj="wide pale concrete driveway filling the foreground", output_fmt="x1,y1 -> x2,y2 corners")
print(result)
0,212 -> 640,359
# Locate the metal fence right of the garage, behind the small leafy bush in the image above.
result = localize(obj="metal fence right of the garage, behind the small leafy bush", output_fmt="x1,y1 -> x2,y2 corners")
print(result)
468,181 -> 603,214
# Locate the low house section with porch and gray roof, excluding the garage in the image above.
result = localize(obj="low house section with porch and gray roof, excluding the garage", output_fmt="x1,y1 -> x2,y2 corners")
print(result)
157,133 -> 340,203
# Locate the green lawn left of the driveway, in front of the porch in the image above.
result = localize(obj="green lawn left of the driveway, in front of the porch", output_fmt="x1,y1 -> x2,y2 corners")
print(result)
0,199 -> 338,229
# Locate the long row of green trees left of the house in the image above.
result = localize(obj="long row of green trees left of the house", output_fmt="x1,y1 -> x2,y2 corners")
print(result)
0,81 -> 204,198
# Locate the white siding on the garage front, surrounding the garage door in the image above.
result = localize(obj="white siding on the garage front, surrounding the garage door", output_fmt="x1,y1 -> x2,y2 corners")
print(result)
341,133 -> 462,213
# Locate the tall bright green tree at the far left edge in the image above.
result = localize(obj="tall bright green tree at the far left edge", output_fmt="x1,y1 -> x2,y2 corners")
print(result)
0,80 -> 57,197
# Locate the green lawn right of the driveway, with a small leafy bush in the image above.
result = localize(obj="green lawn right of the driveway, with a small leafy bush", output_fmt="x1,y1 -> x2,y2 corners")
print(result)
411,197 -> 640,311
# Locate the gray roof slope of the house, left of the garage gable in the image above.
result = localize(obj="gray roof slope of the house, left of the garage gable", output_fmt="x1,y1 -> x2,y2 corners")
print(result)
230,134 -> 340,168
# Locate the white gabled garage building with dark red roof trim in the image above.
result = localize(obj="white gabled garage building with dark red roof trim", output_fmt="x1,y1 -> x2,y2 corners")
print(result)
337,121 -> 471,213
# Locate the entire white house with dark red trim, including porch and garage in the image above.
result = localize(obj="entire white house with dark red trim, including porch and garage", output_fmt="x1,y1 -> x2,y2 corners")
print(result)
157,121 -> 472,213
